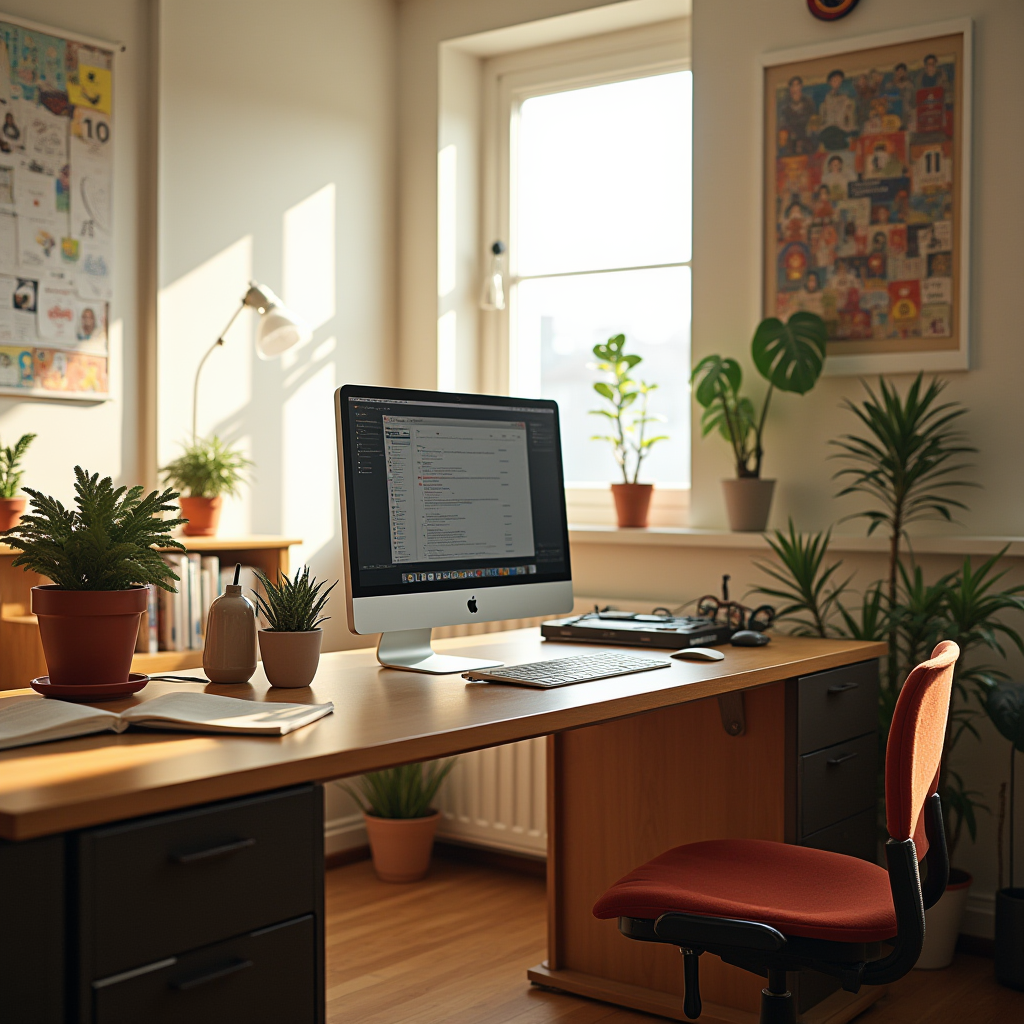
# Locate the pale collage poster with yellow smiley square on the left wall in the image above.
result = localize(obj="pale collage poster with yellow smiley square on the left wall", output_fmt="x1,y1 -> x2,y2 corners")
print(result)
0,22 -> 114,398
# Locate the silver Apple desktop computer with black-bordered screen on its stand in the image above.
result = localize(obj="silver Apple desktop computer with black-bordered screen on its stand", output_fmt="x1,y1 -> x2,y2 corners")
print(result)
335,384 -> 572,675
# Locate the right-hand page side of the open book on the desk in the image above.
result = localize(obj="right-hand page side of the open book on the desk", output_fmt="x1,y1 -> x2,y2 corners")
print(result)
121,691 -> 334,736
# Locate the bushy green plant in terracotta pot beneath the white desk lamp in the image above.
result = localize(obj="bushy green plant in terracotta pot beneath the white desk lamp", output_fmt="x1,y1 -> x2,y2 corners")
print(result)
161,434 -> 252,537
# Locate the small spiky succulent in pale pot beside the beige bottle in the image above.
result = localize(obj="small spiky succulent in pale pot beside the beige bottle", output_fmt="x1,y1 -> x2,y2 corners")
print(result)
253,565 -> 338,687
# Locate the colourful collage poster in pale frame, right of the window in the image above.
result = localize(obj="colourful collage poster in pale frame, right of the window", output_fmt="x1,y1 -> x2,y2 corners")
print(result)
761,19 -> 971,375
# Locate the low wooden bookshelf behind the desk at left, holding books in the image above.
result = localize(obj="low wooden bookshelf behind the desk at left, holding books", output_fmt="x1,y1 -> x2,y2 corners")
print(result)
0,536 -> 302,689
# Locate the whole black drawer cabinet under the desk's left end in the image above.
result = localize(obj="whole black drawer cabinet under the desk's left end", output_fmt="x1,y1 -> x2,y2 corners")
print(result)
0,784 -> 325,1024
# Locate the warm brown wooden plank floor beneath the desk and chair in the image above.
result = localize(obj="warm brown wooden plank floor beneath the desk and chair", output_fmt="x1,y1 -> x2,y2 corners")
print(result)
327,859 -> 1024,1024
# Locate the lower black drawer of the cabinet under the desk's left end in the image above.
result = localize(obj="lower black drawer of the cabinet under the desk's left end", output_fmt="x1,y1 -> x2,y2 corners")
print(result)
92,915 -> 316,1024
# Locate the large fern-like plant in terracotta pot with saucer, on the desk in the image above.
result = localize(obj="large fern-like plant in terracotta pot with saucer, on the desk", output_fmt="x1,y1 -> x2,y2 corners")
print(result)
4,466 -> 183,700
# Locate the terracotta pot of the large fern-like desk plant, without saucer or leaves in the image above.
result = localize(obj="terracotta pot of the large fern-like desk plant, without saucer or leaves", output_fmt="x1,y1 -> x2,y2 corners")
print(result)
32,585 -> 148,686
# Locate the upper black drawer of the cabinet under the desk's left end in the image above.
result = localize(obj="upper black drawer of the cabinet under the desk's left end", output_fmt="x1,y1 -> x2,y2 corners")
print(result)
78,785 -> 324,982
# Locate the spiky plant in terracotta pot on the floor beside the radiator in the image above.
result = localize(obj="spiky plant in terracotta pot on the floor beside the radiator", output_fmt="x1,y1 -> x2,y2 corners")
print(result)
344,758 -> 456,882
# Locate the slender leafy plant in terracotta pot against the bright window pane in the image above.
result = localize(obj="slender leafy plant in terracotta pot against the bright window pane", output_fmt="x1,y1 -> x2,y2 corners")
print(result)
590,334 -> 668,526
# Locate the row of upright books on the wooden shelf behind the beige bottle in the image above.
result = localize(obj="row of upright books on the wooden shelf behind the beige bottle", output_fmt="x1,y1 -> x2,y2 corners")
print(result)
135,552 -> 256,654
